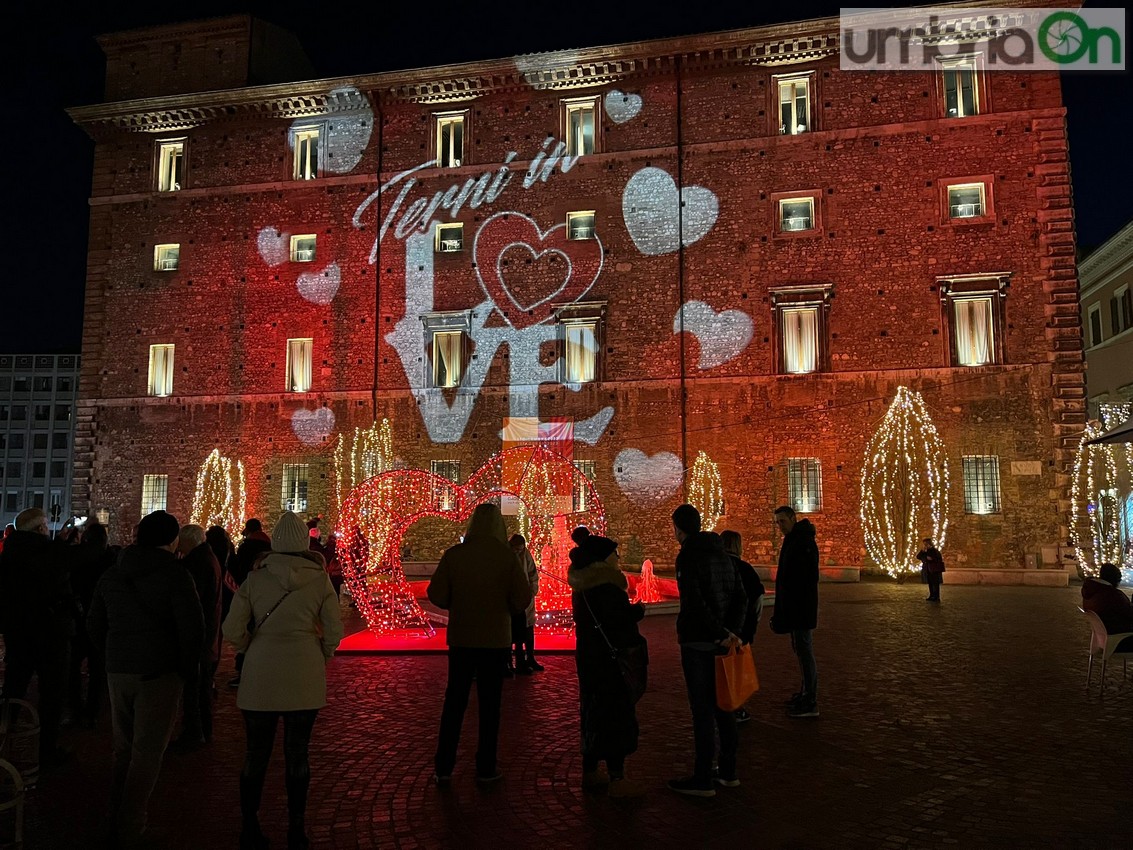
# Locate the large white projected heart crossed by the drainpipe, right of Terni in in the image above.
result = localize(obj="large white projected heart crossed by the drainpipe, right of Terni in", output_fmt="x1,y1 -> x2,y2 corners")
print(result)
622,167 -> 719,256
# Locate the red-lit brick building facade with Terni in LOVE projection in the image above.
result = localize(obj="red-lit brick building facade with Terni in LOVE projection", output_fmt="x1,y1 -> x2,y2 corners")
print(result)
71,9 -> 1084,569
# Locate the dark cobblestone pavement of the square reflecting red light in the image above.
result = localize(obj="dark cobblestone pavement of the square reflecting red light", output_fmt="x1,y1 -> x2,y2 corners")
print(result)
11,581 -> 1133,850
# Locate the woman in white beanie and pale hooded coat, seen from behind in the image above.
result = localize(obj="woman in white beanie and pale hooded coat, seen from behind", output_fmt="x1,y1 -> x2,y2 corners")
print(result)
224,511 -> 342,850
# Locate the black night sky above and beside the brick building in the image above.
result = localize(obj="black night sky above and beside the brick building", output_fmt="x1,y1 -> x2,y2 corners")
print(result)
0,0 -> 1133,352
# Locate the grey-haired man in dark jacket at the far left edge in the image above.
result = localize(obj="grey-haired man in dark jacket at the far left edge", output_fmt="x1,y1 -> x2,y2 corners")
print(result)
0,508 -> 78,767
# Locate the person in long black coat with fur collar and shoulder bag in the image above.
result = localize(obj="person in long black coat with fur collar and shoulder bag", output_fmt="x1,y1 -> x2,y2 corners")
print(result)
567,535 -> 645,797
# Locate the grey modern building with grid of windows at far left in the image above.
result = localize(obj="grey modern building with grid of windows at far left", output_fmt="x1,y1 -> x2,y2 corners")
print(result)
0,355 -> 79,529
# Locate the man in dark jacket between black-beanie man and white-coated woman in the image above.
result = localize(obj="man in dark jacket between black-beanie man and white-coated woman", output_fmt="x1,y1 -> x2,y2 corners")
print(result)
172,525 -> 221,750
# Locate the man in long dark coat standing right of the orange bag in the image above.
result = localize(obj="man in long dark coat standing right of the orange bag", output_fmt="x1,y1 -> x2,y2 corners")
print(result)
772,505 -> 818,717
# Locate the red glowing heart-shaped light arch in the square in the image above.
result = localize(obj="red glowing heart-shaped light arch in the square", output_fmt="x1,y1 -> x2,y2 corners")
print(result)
335,445 -> 606,636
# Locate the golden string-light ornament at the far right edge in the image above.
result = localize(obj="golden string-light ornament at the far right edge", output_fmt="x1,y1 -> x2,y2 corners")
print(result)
1071,403 -> 1133,576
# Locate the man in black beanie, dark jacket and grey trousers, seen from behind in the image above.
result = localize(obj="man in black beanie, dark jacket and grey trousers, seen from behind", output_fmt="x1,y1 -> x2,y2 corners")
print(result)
87,511 -> 204,847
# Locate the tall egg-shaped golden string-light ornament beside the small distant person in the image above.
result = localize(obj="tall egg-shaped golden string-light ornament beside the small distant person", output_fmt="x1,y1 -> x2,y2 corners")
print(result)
861,386 -> 948,577
